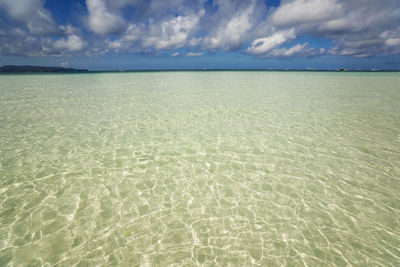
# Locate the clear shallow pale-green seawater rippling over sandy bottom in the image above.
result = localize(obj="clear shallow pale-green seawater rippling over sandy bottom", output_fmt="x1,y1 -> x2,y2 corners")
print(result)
0,72 -> 400,266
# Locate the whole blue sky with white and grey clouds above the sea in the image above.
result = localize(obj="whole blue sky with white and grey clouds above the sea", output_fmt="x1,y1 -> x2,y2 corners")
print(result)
0,0 -> 400,70
